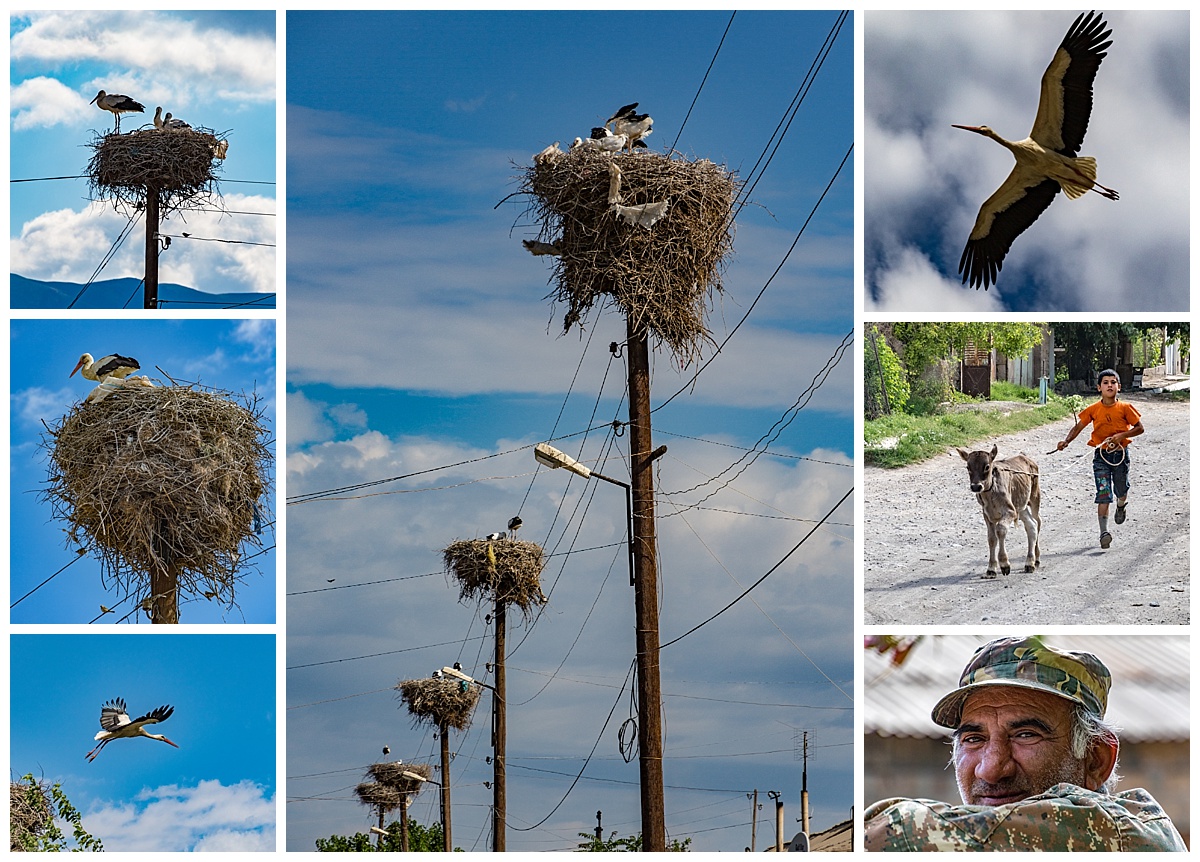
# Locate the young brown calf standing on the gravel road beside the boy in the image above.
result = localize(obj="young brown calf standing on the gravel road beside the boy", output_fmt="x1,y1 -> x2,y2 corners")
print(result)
959,447 -> 1042,577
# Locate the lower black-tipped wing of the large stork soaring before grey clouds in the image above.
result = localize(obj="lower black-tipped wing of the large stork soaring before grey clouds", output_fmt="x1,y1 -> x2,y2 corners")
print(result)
959,170 -> 1058,291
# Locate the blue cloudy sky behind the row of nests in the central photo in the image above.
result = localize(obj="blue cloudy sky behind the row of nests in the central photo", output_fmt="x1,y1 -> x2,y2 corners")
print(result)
287,12 -> 856,851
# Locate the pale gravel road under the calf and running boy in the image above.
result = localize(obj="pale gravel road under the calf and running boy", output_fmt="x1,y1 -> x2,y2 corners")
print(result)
863,394 -> 1192,625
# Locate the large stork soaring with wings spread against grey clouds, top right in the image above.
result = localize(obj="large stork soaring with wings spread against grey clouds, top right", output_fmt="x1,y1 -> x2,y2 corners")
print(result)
952,12 -> 1120,291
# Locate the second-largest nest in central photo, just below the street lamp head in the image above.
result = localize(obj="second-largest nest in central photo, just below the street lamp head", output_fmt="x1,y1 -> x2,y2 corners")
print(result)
442,539 -> 546,619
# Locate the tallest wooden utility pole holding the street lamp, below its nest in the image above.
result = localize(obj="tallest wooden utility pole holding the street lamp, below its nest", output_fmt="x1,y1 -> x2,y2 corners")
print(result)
625,316 -> 667,852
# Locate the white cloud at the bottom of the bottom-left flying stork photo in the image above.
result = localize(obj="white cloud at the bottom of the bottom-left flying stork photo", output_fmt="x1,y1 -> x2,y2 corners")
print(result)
84,780 -> 275,852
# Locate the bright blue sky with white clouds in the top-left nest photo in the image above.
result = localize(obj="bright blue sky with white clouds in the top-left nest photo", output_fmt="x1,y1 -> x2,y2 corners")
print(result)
8,10 -> 276,300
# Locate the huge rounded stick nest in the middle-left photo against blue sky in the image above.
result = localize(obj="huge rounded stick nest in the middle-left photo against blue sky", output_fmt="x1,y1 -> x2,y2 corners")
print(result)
42,385 -> 272,607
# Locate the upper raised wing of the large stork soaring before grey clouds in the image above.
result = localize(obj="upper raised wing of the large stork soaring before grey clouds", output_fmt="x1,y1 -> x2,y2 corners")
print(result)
1030,12 -> 1112,156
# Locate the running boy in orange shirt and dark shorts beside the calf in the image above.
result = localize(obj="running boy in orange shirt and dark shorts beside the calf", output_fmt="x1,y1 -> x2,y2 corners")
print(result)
1057,369 -> 1146,549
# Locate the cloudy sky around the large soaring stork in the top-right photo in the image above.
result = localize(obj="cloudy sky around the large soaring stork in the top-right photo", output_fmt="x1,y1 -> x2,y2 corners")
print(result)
862,11 -> 1190,313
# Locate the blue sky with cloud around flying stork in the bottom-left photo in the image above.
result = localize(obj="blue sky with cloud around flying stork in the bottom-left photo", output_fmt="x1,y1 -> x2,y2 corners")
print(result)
8,634 -> 276,851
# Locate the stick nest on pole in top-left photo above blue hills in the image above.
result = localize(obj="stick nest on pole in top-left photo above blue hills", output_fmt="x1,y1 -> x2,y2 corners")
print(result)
88,128 -> 228,210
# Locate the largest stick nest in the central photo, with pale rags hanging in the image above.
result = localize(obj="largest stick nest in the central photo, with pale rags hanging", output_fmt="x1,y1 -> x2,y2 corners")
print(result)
521,146 -> 738,366
